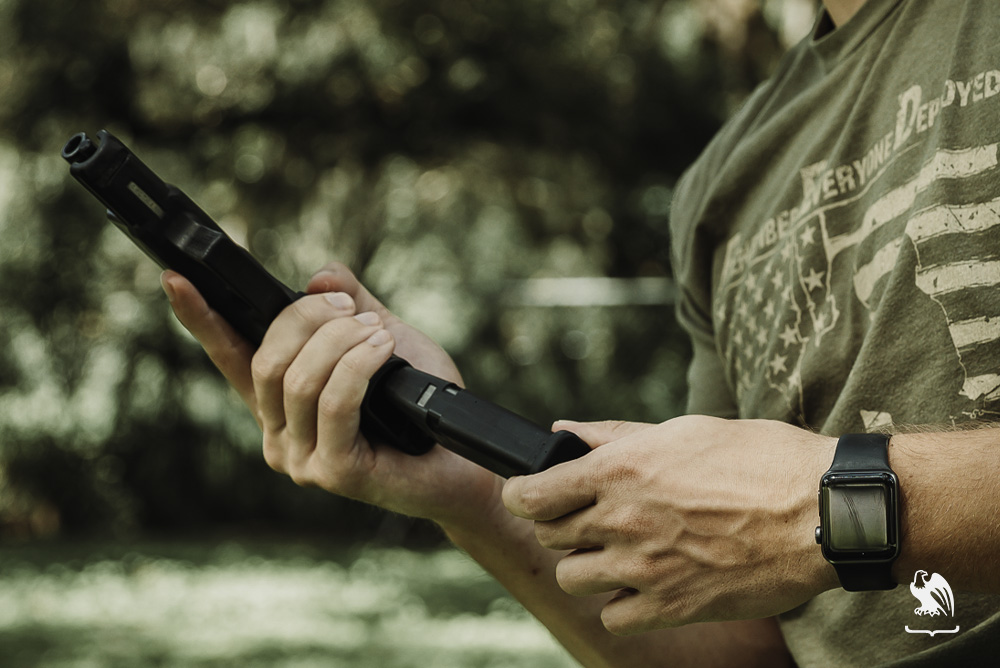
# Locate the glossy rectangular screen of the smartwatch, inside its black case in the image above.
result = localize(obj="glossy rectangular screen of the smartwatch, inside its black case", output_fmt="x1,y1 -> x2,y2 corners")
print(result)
827,484 -> 889,552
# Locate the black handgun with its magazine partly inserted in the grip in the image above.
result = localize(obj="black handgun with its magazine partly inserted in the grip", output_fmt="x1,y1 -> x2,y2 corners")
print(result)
62,130 -> 590,477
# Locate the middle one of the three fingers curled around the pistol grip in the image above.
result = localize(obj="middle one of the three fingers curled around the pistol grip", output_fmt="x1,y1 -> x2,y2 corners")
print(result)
284,311 -> 382,444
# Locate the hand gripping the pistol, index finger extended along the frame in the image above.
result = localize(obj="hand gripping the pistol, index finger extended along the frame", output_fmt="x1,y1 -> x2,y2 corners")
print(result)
162,263 -> 503,525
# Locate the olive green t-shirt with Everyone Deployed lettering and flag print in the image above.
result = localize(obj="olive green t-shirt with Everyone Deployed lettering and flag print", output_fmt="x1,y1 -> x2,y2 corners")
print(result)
671,0 -> 1000,668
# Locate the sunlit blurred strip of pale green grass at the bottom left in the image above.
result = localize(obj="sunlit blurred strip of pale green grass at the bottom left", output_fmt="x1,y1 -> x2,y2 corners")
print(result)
0,540 -> 576,668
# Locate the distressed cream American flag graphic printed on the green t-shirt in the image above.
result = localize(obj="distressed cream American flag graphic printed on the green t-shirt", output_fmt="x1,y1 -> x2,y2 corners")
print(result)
715,144 -> 1000,428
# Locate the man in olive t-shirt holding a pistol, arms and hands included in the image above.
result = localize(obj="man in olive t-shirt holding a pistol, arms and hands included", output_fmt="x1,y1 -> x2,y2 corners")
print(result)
163,0 -> 1000,666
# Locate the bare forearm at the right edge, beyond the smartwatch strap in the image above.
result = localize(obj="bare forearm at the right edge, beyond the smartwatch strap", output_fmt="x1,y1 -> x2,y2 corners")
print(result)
889,427 -> 1000,594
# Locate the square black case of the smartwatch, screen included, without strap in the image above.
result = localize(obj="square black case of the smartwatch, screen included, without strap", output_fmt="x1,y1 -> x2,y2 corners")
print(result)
820,473 -> 899,561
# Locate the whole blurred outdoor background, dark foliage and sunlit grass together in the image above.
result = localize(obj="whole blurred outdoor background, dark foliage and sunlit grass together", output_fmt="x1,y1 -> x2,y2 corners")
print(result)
0,0 -> 817,668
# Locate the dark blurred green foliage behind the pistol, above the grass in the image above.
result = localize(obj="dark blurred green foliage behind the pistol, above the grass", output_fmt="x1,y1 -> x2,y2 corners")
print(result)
0,0 -> 815,536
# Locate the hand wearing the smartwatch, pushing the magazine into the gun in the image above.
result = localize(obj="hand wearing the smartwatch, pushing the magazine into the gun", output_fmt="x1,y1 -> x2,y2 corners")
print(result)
503,416 -> 837,634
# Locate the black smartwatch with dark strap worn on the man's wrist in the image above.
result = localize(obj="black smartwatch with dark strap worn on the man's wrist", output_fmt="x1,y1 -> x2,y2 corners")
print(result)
816,434 -> 899,591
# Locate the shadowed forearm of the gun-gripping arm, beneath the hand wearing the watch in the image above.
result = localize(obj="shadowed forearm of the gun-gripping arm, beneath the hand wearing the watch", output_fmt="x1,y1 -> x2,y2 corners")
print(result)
436,508 -> 791,668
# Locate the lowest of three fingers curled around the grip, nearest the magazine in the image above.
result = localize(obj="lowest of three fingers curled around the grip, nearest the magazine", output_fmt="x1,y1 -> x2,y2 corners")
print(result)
316,329 -> 395,482
